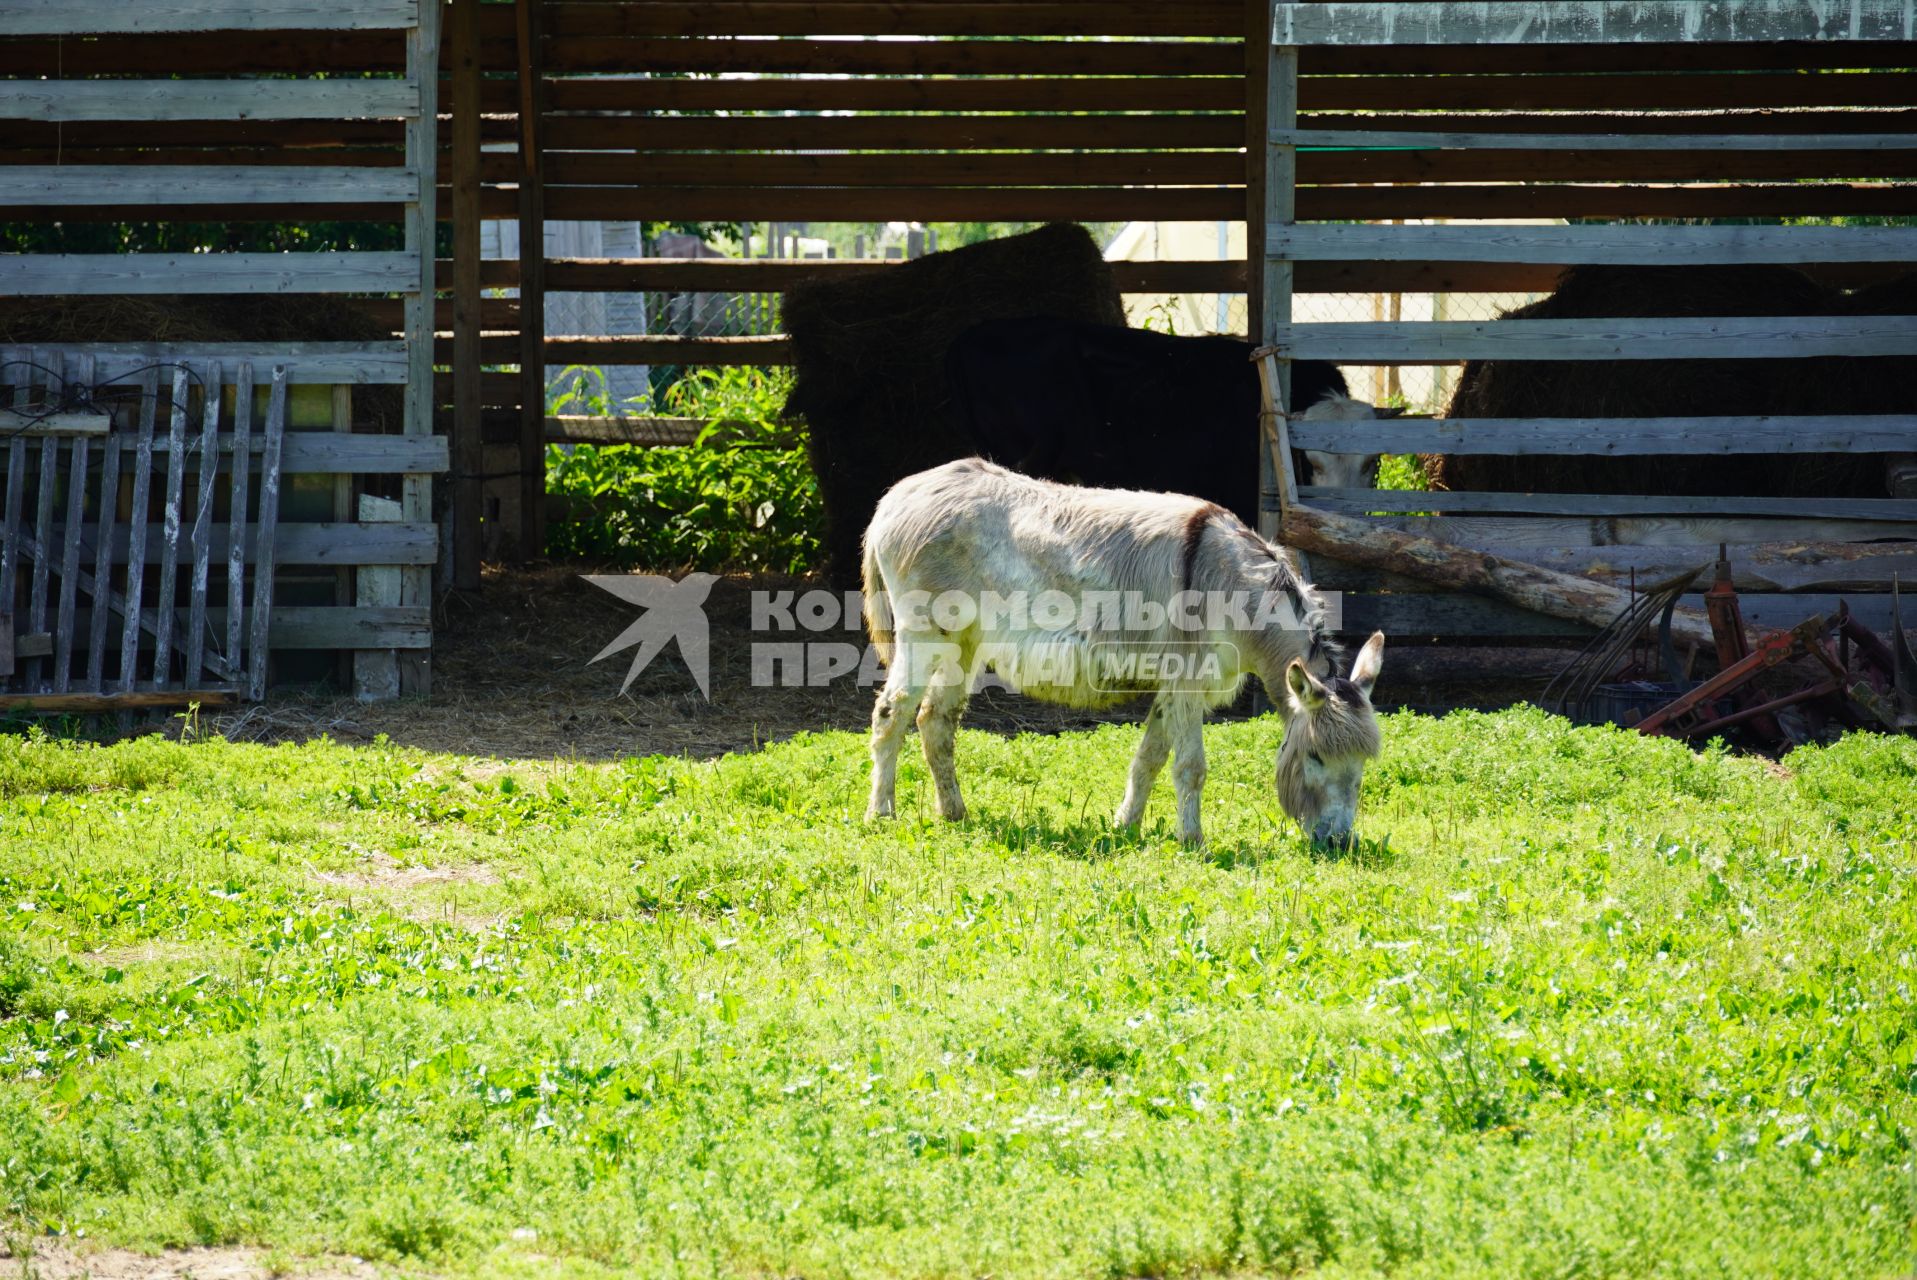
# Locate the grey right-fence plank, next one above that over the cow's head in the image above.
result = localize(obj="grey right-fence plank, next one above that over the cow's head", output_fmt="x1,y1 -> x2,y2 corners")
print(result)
1265,224 -> 1917,266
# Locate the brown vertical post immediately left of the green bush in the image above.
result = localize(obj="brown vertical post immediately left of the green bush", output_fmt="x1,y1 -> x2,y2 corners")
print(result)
516,0 -> 546,561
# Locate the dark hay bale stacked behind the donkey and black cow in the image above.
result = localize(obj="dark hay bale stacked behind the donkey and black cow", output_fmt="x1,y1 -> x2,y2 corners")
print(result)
784,222 -> 1125,583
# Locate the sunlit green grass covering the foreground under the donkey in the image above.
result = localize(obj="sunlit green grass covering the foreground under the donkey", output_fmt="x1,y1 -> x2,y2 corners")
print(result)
0,711 -> 1917,1276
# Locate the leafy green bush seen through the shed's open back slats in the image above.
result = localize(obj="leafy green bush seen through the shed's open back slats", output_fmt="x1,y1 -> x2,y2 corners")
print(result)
546,368 -> 820,573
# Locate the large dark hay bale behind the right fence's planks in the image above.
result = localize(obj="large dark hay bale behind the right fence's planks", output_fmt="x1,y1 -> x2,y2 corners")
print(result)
1426,266 -> 1917,496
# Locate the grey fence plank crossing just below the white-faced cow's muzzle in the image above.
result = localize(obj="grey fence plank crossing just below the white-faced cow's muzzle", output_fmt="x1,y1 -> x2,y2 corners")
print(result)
1292,414 -> 1917,456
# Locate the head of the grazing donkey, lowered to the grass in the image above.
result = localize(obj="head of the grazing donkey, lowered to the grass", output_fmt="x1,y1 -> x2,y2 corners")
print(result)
1279,630 -> 1384,845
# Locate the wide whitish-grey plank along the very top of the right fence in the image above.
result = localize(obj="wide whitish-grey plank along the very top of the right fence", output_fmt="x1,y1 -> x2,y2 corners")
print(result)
1271,0 -> 1917,46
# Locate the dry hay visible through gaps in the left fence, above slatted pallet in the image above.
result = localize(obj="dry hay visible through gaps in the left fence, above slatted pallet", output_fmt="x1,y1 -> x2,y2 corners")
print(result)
0,293 -> 404,431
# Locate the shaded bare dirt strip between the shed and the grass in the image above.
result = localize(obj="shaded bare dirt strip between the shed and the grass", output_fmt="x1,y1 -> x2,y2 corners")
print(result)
169,565 -> 1568,778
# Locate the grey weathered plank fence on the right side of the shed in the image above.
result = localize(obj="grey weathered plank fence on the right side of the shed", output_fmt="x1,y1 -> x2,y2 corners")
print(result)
1258,0 -> 1917,636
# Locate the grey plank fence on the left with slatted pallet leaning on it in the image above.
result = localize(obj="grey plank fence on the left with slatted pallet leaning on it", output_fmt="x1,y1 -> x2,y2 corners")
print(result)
0,0 -> 447,707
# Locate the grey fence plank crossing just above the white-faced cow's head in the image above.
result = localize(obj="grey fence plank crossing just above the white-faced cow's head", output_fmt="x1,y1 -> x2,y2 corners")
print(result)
1265,316 -> 1917,364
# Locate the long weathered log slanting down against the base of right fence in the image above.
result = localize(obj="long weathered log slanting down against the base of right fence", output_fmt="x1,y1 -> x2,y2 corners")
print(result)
1281,504 -> 1716,646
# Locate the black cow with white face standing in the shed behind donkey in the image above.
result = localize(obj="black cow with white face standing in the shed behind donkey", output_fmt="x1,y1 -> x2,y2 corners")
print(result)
945,316 -> 1374,527
